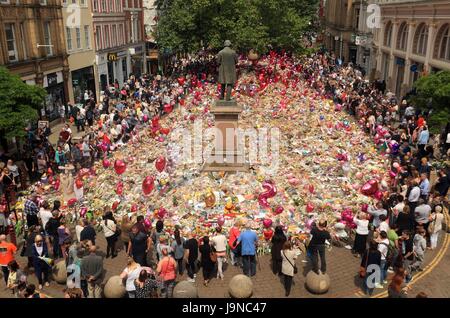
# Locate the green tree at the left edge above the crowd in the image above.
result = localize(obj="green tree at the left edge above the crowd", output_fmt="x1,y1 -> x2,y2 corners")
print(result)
0,67 -> 47,139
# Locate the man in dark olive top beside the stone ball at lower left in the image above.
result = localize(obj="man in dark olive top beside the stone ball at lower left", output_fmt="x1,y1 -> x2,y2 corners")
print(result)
81,245 -> 103,298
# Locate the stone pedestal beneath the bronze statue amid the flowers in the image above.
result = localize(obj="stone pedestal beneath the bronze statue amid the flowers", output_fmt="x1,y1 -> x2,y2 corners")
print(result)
202,100 -> 248,172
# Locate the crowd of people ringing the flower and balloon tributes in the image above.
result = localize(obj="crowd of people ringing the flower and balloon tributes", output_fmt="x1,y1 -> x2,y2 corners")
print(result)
0,47 -> 450,298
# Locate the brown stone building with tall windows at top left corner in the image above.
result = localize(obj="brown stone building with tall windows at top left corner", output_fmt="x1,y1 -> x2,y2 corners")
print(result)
0,0 -> 69,121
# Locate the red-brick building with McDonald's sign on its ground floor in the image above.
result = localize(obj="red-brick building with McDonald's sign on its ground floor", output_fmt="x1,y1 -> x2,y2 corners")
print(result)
92,0 -> 145,91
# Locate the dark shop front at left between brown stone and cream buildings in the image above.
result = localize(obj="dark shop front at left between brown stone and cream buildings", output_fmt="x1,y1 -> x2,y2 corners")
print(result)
41,72 -> 66,121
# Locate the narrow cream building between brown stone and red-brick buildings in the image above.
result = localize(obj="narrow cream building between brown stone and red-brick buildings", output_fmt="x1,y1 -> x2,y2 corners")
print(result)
62,0 -> 99,104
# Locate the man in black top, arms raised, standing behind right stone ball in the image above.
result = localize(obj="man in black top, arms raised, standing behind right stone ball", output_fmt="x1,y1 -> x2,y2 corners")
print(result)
308,220 -> 331,275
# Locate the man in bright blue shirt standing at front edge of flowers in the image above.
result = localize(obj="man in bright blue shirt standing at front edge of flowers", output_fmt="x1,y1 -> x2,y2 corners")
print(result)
237,221 -> 258,277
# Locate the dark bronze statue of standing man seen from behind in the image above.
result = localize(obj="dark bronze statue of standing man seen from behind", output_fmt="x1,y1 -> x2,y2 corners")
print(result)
217,40 -> 238,101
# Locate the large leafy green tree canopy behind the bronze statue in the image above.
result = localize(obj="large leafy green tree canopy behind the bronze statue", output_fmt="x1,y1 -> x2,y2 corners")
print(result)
155,0 -> 319,53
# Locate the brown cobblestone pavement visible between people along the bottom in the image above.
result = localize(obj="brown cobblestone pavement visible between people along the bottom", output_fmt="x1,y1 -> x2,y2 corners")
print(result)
0,226 -> 450,298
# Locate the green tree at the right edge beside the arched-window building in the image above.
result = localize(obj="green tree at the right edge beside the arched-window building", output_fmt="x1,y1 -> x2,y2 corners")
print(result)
411,71 -> 450,133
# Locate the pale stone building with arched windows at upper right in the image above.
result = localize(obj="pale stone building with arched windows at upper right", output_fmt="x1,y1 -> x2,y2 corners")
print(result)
373,0 -> 450,97
